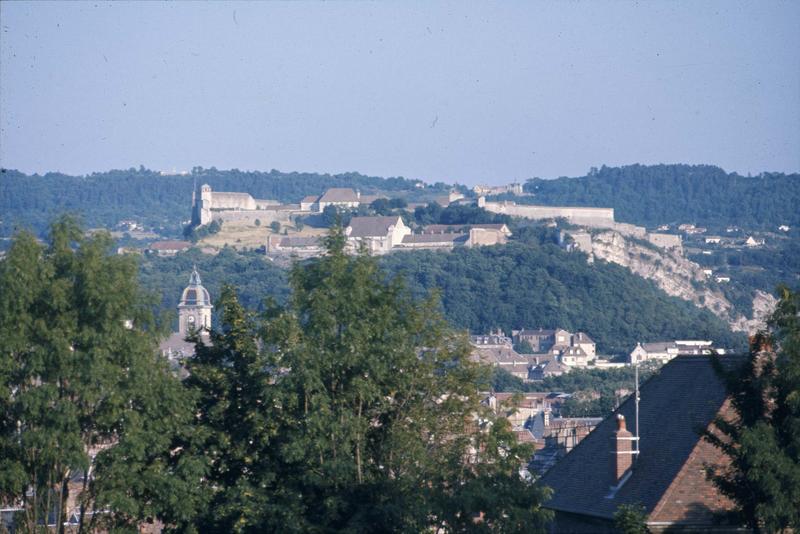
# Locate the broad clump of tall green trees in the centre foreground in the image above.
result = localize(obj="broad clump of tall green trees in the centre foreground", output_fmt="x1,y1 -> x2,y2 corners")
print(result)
187,226 -> 549,532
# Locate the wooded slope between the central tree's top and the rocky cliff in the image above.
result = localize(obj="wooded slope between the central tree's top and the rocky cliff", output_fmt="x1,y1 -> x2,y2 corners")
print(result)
382,242 -> 744,354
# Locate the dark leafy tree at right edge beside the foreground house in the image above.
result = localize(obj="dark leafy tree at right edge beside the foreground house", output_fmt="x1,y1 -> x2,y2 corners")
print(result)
705,288 -> 800,532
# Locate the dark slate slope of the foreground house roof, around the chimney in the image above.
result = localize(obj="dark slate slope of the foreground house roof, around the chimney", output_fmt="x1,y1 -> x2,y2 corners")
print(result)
539,356 -> 743,518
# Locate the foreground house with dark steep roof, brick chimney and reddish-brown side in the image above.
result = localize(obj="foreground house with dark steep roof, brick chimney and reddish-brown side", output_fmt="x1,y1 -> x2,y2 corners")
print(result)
539,356 -> 742,533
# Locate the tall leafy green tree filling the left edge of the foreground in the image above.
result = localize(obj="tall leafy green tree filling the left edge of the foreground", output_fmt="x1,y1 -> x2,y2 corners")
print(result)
0,218 -> 200,531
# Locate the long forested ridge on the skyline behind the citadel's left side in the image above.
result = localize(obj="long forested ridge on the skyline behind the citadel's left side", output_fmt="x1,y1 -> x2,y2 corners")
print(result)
0,167 -> 449,237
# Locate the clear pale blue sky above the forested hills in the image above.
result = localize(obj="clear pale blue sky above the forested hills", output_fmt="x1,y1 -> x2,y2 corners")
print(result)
0,1 -> 800,184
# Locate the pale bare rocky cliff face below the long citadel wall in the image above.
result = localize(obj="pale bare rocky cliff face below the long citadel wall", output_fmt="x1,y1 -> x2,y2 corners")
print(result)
579,231 -> 776,333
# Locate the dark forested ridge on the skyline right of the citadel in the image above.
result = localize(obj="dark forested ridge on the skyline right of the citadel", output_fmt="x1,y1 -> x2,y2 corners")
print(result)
515,165 -> 800,230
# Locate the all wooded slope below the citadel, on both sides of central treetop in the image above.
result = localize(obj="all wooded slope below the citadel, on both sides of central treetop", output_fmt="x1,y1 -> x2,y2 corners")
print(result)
140,234 -> 744,354
